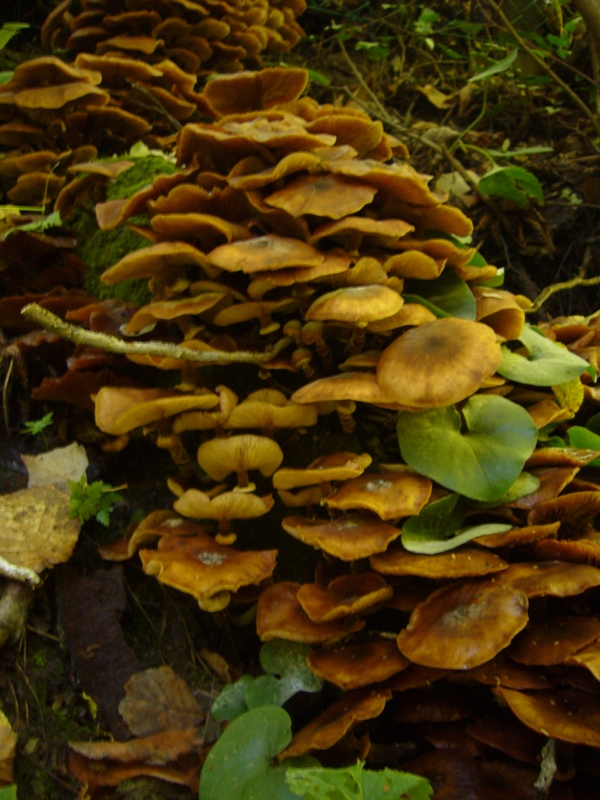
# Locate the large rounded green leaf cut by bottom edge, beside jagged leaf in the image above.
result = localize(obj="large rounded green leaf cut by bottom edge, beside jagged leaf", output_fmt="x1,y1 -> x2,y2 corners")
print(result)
199,706 -> 298,800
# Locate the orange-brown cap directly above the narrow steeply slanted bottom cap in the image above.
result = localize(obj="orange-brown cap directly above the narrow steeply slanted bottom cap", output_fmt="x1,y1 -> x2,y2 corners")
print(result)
306,639 -> 410,692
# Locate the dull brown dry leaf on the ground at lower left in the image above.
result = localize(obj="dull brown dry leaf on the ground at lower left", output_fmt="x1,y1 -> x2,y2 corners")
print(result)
119,667 -> 205,736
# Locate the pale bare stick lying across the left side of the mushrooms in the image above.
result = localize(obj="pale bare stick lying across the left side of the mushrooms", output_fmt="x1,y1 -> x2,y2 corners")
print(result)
21,303 -> 293,364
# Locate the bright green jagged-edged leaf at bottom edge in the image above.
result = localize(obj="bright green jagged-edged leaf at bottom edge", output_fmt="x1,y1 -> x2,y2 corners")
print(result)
286,761 -> 433,800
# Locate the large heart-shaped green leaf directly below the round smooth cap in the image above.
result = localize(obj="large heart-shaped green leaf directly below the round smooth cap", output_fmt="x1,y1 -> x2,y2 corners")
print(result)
397,395 -> 537,501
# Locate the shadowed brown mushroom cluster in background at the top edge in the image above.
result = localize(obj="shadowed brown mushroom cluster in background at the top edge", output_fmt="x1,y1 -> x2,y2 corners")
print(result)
42,0 -> 306,76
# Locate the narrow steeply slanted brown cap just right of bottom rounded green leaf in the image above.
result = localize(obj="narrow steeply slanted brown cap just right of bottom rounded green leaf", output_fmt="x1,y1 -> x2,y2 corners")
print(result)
279,689 -> 392,760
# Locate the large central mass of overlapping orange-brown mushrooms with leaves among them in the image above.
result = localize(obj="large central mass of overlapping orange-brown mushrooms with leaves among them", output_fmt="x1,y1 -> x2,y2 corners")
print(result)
45,69 -> 600,800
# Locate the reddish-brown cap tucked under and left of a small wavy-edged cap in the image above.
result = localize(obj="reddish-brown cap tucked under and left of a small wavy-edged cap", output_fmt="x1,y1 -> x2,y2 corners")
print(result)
256,581 -> 365,644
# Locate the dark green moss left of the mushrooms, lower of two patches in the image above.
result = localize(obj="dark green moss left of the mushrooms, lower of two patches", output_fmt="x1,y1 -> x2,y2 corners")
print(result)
70,211 -> 152,306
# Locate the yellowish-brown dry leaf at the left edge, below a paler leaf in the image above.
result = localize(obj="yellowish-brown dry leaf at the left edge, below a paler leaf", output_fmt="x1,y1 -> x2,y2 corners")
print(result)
0,484 -> 81,572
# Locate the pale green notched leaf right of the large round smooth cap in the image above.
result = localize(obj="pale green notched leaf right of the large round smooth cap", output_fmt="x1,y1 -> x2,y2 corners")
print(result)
497,325 -> 589,386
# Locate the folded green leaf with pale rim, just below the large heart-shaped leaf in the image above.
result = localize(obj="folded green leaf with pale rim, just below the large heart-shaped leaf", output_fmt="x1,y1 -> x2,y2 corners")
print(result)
402,494 -> 512,555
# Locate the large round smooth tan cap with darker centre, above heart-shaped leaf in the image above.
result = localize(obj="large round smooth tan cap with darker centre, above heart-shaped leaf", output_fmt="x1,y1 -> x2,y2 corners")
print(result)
376,317 -> 502,408
